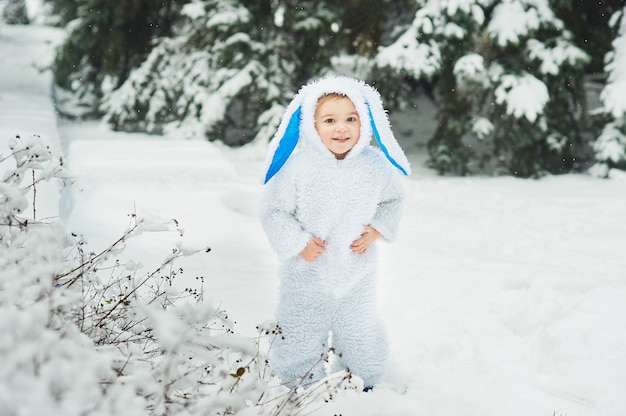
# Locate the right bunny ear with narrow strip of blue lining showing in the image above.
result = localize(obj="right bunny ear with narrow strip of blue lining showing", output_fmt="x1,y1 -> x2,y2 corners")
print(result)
365,95 -> 411,176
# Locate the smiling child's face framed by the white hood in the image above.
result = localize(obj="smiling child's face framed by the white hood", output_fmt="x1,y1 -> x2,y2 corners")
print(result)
315,96 -> 361,159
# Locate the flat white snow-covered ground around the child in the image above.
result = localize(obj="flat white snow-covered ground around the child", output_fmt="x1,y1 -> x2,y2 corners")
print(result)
0,21 -> 626,416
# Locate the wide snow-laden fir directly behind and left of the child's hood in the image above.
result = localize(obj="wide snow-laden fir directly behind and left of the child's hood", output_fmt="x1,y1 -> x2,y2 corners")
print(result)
101,0 -> 340,145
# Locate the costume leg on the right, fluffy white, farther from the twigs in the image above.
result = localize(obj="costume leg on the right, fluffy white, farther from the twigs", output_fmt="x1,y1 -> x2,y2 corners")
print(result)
332,274 -> 389,386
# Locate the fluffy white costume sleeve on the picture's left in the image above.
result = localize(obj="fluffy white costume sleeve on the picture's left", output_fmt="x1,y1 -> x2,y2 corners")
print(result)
259,171 -> 313,261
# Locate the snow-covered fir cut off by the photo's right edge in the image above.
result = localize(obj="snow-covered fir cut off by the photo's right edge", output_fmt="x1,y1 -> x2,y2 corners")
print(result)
593,8 -> 626,177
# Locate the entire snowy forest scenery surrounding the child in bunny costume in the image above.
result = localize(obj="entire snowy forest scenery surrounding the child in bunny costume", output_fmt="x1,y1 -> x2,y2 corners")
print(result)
0,0 -> 626,416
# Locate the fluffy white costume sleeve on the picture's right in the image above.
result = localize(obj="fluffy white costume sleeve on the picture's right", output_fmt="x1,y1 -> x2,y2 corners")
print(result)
370,172 -> 404,241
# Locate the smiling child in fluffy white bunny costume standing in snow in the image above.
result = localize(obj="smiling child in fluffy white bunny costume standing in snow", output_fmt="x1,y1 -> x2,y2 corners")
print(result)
260,77 -> 410,390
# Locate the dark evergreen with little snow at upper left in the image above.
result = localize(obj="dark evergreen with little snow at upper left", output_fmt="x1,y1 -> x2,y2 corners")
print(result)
53,0 -> 186,113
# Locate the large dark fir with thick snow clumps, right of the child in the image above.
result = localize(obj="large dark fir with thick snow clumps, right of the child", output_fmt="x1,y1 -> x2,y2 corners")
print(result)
377,0 -> 588,177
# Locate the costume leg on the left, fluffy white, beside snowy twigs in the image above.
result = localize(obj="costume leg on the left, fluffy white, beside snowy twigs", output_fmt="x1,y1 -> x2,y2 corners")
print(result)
270,264 -> 330,388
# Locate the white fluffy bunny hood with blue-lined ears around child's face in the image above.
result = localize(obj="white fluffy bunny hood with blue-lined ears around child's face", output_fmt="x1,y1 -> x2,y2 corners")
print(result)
264,76 -> 411,183
